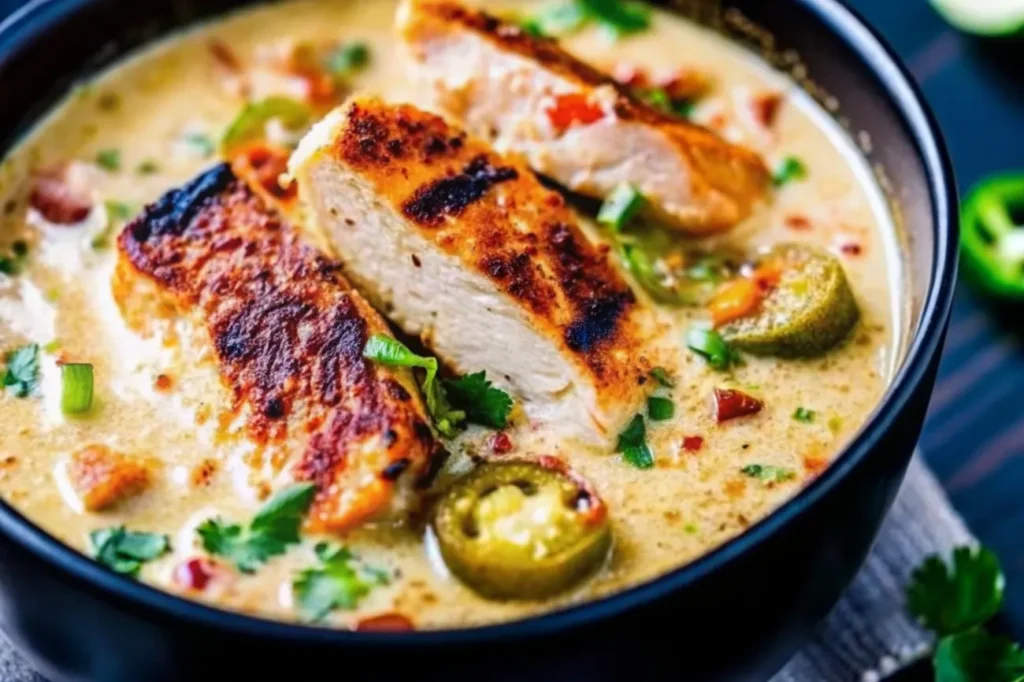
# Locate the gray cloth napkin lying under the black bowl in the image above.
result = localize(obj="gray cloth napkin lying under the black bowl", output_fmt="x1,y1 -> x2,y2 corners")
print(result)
0,450 -> 974,682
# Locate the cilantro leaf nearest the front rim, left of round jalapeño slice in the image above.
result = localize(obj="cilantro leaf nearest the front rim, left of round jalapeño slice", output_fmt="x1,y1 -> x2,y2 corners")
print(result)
292,543 -> 390,622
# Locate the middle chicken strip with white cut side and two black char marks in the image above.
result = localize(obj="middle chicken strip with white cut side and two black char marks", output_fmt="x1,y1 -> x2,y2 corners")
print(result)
290,97 -> 656,445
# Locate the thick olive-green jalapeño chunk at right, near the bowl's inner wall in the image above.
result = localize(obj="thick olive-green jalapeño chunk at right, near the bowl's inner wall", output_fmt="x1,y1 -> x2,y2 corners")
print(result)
712,244 -> 860,357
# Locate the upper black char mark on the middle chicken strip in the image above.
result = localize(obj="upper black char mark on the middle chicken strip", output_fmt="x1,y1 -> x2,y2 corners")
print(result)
402,154 -> 519,227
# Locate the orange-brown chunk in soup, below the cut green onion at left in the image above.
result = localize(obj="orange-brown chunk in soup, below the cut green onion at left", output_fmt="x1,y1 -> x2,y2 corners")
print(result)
68,445 -> 150,511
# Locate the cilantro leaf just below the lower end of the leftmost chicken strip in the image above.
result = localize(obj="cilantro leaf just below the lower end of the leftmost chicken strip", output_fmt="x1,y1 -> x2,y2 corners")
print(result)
196,483 -> 316,573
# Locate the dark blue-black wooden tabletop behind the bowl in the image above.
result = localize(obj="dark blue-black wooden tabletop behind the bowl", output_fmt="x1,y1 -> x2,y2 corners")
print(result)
0,0 -> 1024,637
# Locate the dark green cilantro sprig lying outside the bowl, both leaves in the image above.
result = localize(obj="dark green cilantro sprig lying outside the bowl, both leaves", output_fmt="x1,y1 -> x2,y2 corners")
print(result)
906,547 -> 1024,682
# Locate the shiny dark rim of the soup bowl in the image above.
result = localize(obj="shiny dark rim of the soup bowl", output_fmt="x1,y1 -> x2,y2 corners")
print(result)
0,0 -> 958,647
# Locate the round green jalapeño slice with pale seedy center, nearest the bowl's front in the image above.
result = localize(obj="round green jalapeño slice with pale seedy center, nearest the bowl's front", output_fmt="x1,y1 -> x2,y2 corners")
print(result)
433,461 -> 611,599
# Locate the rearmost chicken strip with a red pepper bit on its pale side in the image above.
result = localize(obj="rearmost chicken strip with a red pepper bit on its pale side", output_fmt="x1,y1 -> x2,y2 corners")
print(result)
398,0 -> 770,236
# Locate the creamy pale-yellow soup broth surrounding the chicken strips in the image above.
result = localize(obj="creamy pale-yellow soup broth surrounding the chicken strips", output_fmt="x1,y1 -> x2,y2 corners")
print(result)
0,0 -> 901,629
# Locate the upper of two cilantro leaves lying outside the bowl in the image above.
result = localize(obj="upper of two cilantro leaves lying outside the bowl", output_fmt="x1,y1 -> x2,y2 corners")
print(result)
906,547 -> 1005,636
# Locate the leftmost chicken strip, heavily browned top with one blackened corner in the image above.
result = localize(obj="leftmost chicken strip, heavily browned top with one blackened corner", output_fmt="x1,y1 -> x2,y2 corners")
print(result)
114,165 -> 438,530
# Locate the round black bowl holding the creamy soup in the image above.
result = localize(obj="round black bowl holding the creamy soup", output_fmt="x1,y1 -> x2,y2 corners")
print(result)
0,0 -> 957,682
